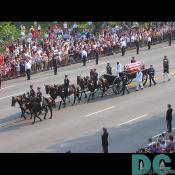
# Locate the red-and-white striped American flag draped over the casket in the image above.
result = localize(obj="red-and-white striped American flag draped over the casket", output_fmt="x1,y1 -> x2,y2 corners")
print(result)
124,61 -> 145,72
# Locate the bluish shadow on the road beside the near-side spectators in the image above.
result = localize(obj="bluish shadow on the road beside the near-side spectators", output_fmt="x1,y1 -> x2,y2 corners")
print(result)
46,114 -> 175,153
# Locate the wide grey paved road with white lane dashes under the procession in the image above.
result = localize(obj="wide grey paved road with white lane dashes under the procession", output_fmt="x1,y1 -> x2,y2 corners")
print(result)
0,43 -> 175,153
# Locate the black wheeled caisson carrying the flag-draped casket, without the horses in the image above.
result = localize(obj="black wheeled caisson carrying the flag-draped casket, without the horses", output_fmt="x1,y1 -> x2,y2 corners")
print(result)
100,61 -> 149,94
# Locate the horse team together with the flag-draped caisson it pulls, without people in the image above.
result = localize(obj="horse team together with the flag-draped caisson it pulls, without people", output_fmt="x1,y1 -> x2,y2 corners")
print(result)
12,62 -> 149,123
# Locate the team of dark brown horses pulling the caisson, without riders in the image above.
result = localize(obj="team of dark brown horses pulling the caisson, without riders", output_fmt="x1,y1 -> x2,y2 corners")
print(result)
11,76 -> 112,124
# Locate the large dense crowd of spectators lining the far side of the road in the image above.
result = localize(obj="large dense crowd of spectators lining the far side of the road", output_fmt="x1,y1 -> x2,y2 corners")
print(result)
0,22 -> 175,80
